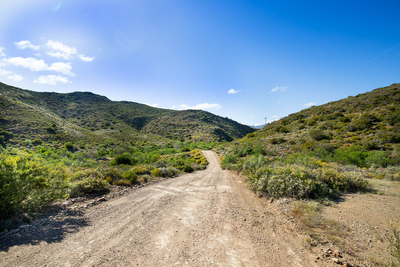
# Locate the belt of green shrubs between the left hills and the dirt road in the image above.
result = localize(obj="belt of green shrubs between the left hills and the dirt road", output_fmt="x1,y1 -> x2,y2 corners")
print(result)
0,140 -> 213,219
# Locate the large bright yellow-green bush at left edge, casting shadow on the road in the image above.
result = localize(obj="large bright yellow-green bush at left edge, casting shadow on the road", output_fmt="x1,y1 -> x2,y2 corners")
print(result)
0,151 -> 69,217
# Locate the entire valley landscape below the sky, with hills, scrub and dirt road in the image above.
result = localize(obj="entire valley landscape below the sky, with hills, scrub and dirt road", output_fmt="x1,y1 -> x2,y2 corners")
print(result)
0,84 -> 400,266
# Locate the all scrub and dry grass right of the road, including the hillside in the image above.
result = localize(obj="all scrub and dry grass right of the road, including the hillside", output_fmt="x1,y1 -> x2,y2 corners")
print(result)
216,84 -> 400,266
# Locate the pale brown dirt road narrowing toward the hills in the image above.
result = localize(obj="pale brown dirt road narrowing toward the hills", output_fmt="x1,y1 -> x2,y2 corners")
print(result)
0,151 -> 317,266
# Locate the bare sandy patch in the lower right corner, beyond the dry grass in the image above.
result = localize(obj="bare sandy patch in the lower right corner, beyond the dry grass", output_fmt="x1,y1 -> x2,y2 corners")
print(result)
324,194 -> 400,266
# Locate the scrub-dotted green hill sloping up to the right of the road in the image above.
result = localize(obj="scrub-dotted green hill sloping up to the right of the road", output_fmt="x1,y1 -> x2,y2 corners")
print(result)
219,84 -> 400,167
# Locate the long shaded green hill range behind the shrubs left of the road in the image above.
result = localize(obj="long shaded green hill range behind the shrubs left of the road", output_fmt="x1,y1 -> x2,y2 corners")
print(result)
0,83 -> 254,147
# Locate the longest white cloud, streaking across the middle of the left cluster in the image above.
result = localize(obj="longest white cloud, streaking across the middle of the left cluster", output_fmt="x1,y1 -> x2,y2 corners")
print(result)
3,57 -> 75,76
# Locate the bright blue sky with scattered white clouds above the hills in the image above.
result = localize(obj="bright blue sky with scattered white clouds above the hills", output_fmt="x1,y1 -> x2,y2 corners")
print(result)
0,0 -> 400,125
